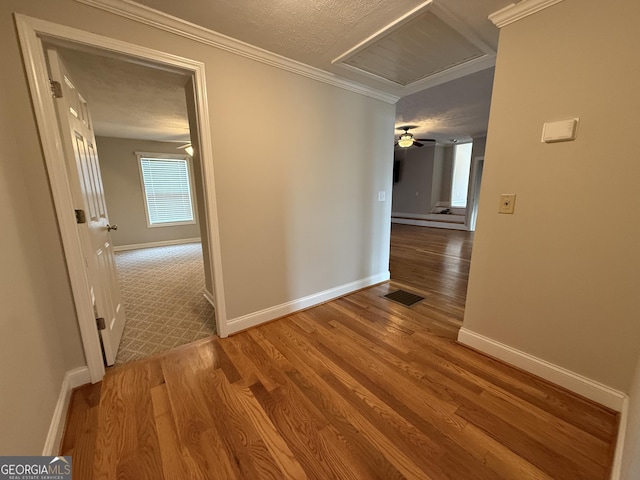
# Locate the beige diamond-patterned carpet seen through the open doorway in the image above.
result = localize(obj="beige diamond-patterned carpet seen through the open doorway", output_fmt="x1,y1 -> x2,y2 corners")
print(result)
116,243 -> 216,365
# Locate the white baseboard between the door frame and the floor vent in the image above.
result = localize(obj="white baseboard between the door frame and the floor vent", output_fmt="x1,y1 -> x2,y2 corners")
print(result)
227,271 -> 390,335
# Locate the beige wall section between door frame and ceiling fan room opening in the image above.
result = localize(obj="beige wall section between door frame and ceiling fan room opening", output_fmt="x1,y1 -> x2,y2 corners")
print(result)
209,60 -> 395,318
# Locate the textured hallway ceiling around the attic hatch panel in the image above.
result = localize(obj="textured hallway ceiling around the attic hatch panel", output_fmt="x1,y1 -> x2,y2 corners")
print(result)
138,0 -> 504,75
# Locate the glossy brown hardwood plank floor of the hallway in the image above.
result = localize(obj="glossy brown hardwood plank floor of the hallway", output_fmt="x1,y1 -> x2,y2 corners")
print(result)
61,225 -> 617,480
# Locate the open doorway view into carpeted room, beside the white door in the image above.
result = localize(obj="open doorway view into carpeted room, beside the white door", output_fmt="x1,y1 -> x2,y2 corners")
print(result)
45,45 -> 216,365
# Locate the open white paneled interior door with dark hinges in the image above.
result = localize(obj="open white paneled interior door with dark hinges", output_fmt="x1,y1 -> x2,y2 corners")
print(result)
47,49 -> 125,365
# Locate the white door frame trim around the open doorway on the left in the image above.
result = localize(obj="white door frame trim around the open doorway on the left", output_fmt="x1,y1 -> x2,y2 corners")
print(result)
14,13 -> 228,383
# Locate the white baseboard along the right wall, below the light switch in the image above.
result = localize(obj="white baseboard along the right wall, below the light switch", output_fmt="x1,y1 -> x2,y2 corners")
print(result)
458,327 -> 627,412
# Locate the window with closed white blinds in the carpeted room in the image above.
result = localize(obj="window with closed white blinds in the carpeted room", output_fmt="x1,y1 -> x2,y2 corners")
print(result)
136,152 -> 196,227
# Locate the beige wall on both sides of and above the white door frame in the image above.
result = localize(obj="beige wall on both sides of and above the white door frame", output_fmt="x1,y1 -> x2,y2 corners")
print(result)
0,0 -> 395,454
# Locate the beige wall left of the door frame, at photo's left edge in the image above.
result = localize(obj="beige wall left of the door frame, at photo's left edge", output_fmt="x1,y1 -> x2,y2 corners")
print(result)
0,78 -> 84,455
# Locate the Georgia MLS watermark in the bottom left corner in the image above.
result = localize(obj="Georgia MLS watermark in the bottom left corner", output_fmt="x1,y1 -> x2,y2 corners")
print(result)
0,457 -> 72,480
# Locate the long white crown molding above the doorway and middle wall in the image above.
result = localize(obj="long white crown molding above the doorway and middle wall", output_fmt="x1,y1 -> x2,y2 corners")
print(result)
75,0 -> 400,104
